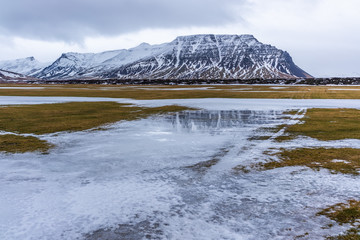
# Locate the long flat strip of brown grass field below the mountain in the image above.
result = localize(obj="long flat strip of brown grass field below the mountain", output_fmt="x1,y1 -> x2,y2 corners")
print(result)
0,84 -> 360,99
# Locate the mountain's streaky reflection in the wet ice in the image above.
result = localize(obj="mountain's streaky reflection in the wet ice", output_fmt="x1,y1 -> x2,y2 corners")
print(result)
168,110 -> 282,130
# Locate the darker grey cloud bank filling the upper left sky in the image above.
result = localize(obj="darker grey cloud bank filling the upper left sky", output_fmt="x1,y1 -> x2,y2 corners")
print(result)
0,0 -> 245,42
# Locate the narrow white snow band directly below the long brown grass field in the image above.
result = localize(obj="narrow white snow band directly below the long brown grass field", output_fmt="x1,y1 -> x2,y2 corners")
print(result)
0,96 -> 360,110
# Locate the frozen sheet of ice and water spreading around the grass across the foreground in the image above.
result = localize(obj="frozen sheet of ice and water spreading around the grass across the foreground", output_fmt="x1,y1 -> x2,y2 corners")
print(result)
0,97 -> 360,240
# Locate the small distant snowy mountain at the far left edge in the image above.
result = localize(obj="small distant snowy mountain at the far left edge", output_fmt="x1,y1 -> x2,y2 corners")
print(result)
0,57 -> 49,75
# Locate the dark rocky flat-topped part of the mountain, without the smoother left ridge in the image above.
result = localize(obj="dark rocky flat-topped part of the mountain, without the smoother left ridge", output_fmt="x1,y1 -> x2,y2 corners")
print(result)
101,35 -> 311,79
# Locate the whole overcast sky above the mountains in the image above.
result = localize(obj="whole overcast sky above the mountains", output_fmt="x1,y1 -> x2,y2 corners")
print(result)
0,0 -> 360,77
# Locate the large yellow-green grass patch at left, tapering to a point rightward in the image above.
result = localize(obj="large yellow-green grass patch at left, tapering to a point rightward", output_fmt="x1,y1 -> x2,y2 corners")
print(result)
0,102 -> 189,134
